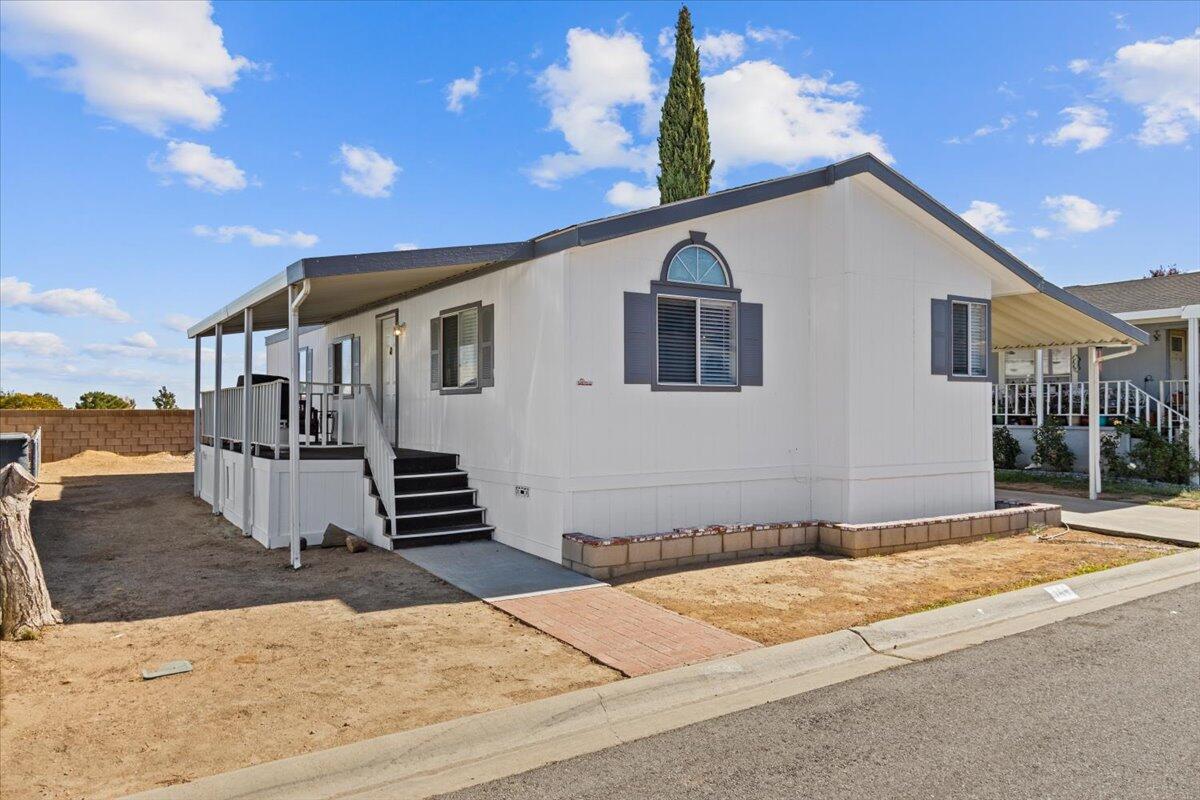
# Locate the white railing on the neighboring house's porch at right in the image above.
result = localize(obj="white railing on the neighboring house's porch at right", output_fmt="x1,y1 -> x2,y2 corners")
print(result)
991,380 -> 1187,440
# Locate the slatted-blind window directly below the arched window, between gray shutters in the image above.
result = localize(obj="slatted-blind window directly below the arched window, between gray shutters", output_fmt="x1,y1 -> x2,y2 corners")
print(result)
658,298 -> 738,386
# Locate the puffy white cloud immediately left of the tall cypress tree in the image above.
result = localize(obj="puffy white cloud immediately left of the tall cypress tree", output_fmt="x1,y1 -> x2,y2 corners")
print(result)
528,28 -> 658,188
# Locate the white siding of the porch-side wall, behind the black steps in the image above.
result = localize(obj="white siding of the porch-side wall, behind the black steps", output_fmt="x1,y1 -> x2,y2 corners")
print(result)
268,253 -> 566,561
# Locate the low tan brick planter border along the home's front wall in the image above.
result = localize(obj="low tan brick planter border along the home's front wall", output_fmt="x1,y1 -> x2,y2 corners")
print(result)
563,500 -> 1062,581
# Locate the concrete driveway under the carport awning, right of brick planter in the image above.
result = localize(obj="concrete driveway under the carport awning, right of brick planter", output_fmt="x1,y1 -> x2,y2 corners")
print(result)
996,489 -> 1200,547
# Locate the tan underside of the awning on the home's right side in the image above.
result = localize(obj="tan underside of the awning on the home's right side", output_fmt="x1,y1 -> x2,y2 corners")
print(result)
991,287 -> 1150,350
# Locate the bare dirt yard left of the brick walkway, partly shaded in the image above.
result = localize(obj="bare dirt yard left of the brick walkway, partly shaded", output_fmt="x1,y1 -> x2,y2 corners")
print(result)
0,452 -> 619,800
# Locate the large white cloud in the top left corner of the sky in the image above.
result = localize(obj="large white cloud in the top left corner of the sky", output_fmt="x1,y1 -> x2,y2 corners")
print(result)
2,2 -> 253,136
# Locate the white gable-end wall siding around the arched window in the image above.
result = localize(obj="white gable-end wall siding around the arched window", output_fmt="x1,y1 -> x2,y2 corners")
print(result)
566,180 -> 992,535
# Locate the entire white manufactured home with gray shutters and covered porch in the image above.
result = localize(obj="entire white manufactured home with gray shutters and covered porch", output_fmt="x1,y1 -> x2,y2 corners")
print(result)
188,156 -> 1148,561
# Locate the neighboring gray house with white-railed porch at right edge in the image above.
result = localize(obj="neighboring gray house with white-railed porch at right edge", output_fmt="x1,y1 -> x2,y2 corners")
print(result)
994,271 -> 1200,465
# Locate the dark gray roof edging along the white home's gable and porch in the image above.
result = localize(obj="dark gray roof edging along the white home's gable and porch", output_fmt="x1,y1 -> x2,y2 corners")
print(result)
187,154 -> 1150,343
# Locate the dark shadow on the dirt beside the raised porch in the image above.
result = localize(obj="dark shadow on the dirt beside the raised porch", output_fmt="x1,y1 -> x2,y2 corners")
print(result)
31,471 -> 463,622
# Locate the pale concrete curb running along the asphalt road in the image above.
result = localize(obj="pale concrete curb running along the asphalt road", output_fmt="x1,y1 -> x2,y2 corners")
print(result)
124,551 -> 1200,800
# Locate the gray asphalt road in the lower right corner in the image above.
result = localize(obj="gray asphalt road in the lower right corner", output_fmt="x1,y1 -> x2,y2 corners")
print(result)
444,584 -> 1200,800
